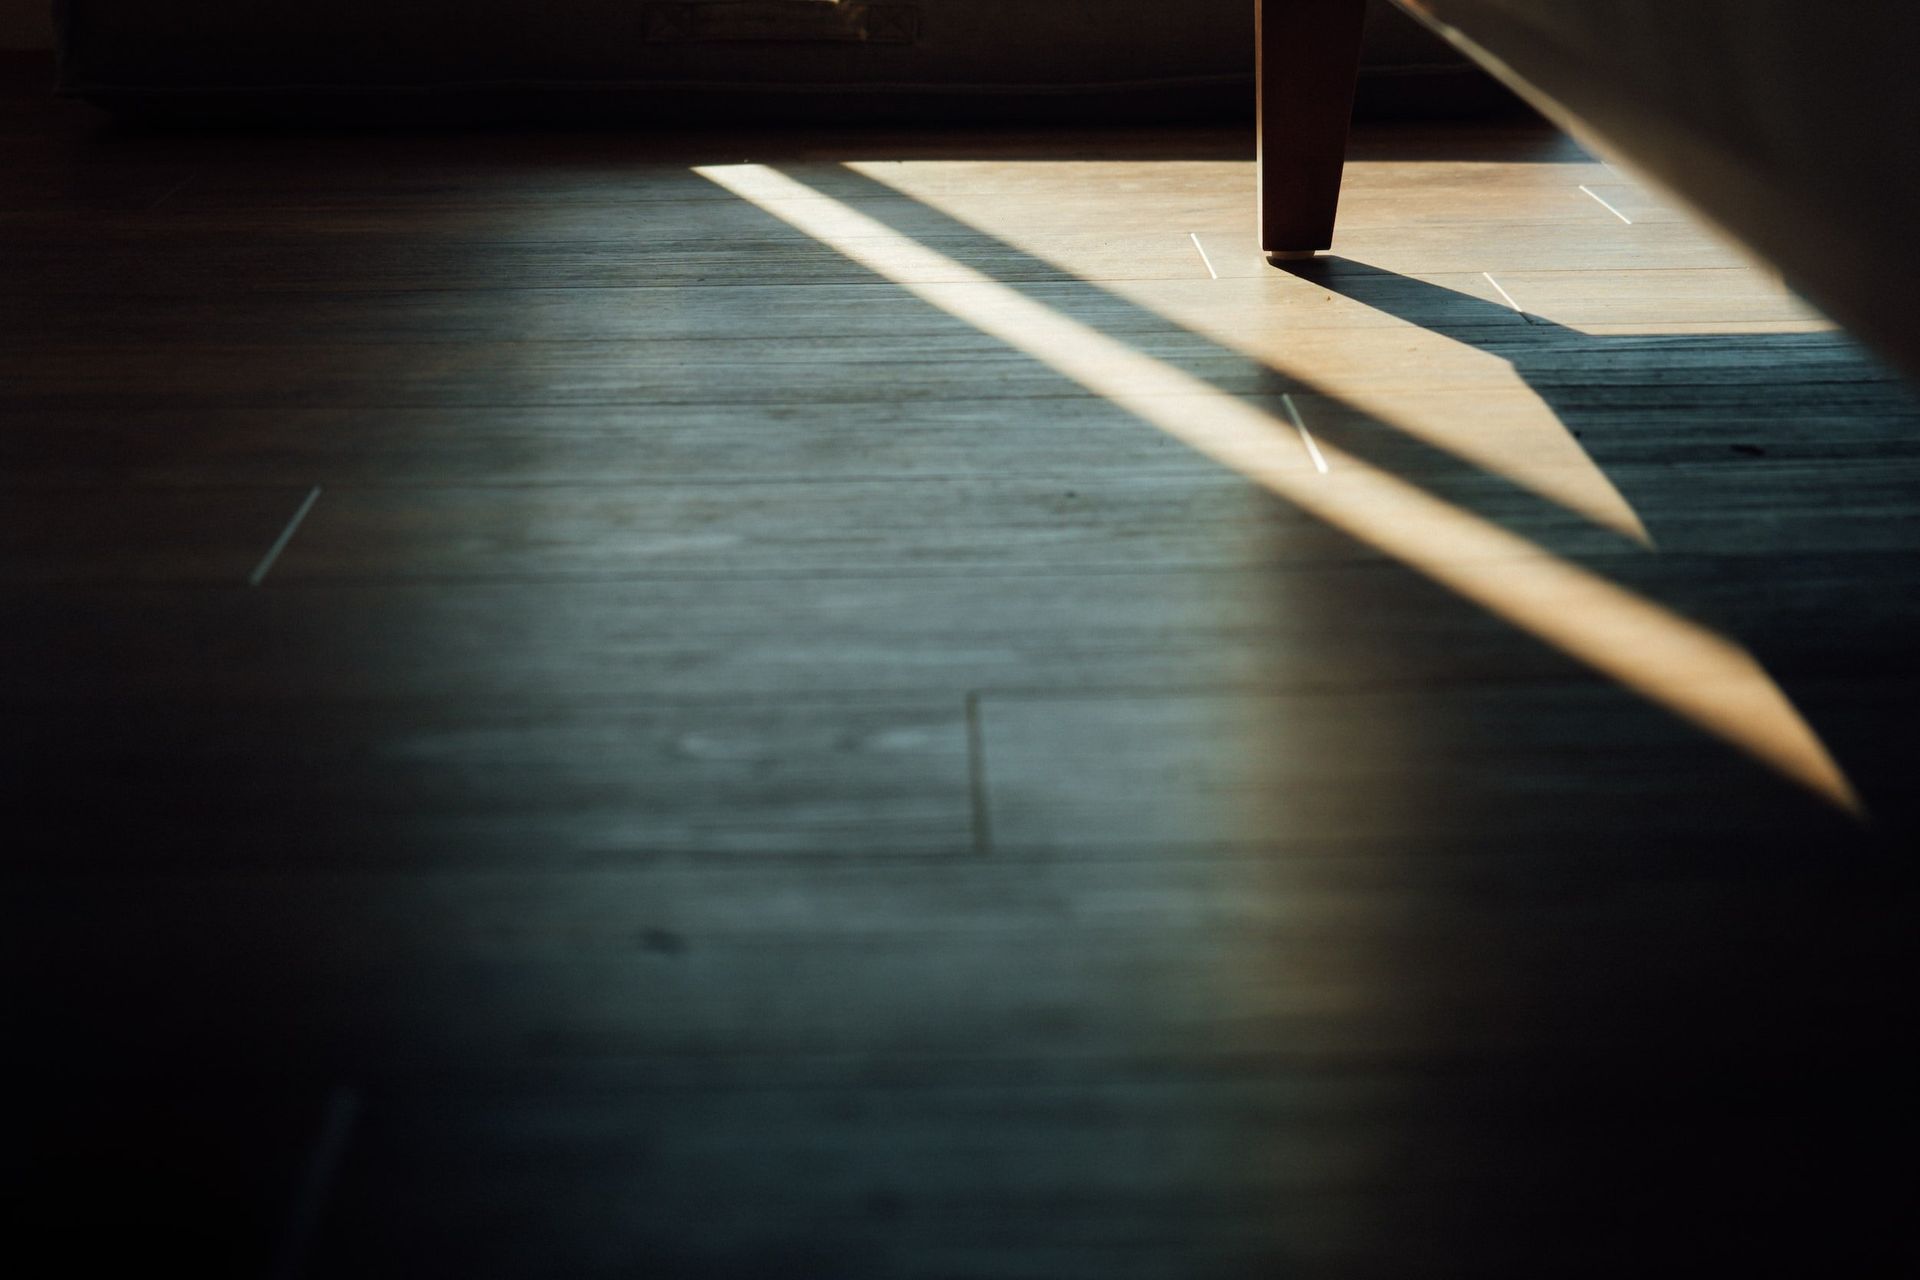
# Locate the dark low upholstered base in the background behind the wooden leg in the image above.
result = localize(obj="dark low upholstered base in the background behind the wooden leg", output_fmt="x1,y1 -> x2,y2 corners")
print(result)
58,0 -> 1513,125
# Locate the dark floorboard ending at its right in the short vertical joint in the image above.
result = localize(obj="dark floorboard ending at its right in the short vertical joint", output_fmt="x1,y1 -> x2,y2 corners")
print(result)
6,691 -> 973,869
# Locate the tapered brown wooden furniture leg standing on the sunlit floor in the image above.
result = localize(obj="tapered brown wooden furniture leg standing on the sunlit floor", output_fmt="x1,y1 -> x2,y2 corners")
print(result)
1254,0 -> 1367,261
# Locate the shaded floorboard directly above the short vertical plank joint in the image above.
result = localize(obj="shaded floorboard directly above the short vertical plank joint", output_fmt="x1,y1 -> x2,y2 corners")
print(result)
15,551 -> 1920,706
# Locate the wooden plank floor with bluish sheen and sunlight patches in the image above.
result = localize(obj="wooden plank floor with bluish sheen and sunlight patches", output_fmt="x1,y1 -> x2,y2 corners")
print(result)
0,62 -> 1920,1280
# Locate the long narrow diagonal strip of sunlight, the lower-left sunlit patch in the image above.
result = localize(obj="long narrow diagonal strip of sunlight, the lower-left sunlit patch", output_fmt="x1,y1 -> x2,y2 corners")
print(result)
695,165 -> 1860,814
